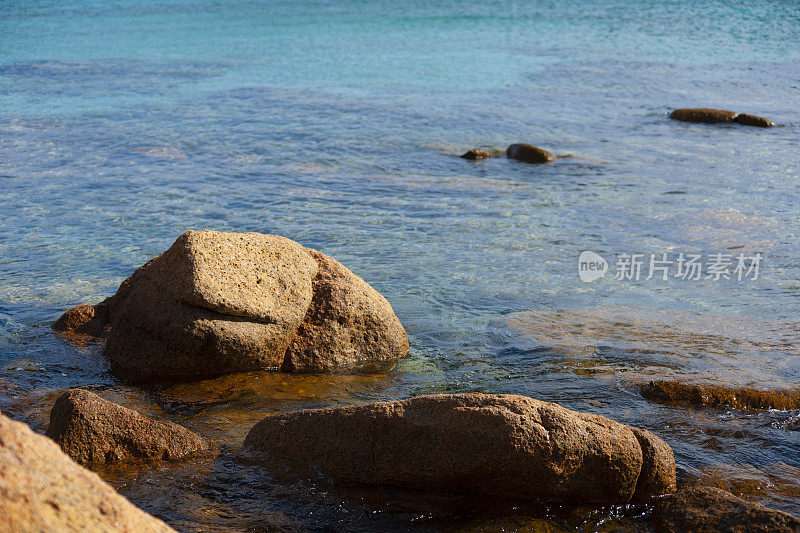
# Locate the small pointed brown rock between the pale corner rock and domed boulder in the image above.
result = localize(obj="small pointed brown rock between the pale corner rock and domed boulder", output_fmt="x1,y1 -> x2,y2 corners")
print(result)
47,389 -> 207,466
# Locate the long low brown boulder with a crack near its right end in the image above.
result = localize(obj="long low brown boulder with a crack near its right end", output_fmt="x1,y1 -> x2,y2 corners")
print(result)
242,394 -> 675,502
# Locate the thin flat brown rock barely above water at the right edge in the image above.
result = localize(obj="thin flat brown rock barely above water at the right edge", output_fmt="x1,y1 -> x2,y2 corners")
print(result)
642,381 -> 800,410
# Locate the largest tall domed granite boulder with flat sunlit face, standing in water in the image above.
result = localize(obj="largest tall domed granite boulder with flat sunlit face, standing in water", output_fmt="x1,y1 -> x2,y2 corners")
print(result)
53,231 -> 408,380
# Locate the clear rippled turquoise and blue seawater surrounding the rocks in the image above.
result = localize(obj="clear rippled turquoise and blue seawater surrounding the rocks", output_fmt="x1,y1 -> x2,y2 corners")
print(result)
0,1 -> 800,530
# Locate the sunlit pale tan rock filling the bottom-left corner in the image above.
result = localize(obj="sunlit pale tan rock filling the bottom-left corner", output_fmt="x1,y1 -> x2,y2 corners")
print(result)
0,415 -> 173,533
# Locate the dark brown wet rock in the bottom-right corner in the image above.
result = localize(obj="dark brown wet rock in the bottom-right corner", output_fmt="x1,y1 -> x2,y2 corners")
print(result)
653,487 -> 800,533
